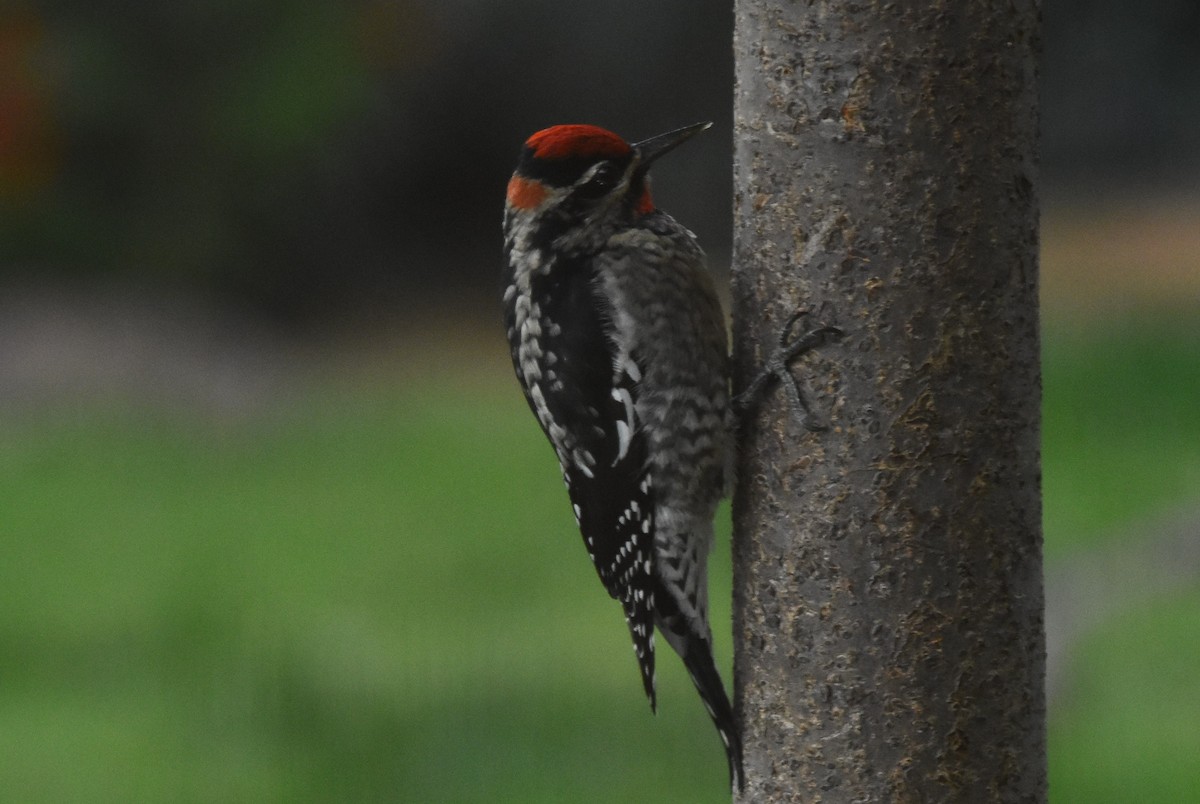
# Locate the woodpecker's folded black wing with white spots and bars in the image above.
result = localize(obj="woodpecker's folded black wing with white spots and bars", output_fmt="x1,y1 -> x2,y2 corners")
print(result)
505,262 -> 654,707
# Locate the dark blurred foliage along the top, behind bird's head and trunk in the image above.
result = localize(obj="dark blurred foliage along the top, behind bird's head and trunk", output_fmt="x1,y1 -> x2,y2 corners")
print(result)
0,0 -> 1200,318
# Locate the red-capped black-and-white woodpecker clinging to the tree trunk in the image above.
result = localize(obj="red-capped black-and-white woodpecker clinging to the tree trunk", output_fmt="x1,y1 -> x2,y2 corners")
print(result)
504,122 -> 834,790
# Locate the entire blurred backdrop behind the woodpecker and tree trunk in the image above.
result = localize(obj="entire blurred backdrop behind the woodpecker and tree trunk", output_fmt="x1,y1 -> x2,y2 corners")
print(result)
0,0 -> 1200,802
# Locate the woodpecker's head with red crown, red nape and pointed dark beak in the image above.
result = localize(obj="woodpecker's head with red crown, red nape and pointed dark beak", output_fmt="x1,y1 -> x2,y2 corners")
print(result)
505,122 -> 713,248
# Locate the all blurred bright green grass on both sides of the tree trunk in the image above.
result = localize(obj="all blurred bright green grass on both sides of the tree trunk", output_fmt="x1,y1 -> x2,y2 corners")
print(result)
0,319 -> 1200,802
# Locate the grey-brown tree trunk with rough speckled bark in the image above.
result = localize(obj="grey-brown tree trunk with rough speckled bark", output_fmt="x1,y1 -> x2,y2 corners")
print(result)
733,0 -> 1045,803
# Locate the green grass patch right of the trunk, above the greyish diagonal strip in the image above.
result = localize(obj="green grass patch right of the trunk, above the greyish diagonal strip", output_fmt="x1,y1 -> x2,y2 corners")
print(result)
1042,312 -> 1200,559
